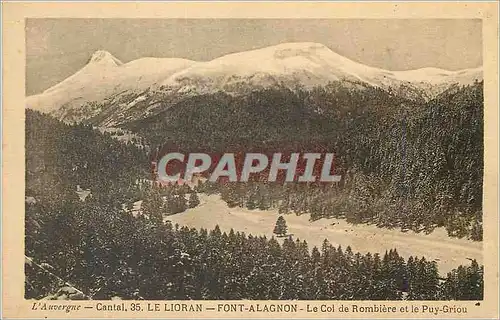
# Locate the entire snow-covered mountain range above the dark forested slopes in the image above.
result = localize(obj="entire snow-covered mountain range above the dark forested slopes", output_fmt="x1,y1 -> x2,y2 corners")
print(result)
26,43 -> 483,126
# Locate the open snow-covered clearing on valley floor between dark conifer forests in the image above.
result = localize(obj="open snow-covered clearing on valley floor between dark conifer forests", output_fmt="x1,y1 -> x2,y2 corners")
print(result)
165,194 -> 483,275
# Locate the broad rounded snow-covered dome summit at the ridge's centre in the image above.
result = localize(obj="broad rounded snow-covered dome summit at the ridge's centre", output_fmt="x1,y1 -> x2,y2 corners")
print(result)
163,42 -> 370,91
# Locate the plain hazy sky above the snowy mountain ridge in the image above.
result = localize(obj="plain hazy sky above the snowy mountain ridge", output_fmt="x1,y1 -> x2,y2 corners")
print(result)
26,19 -> 482,94
